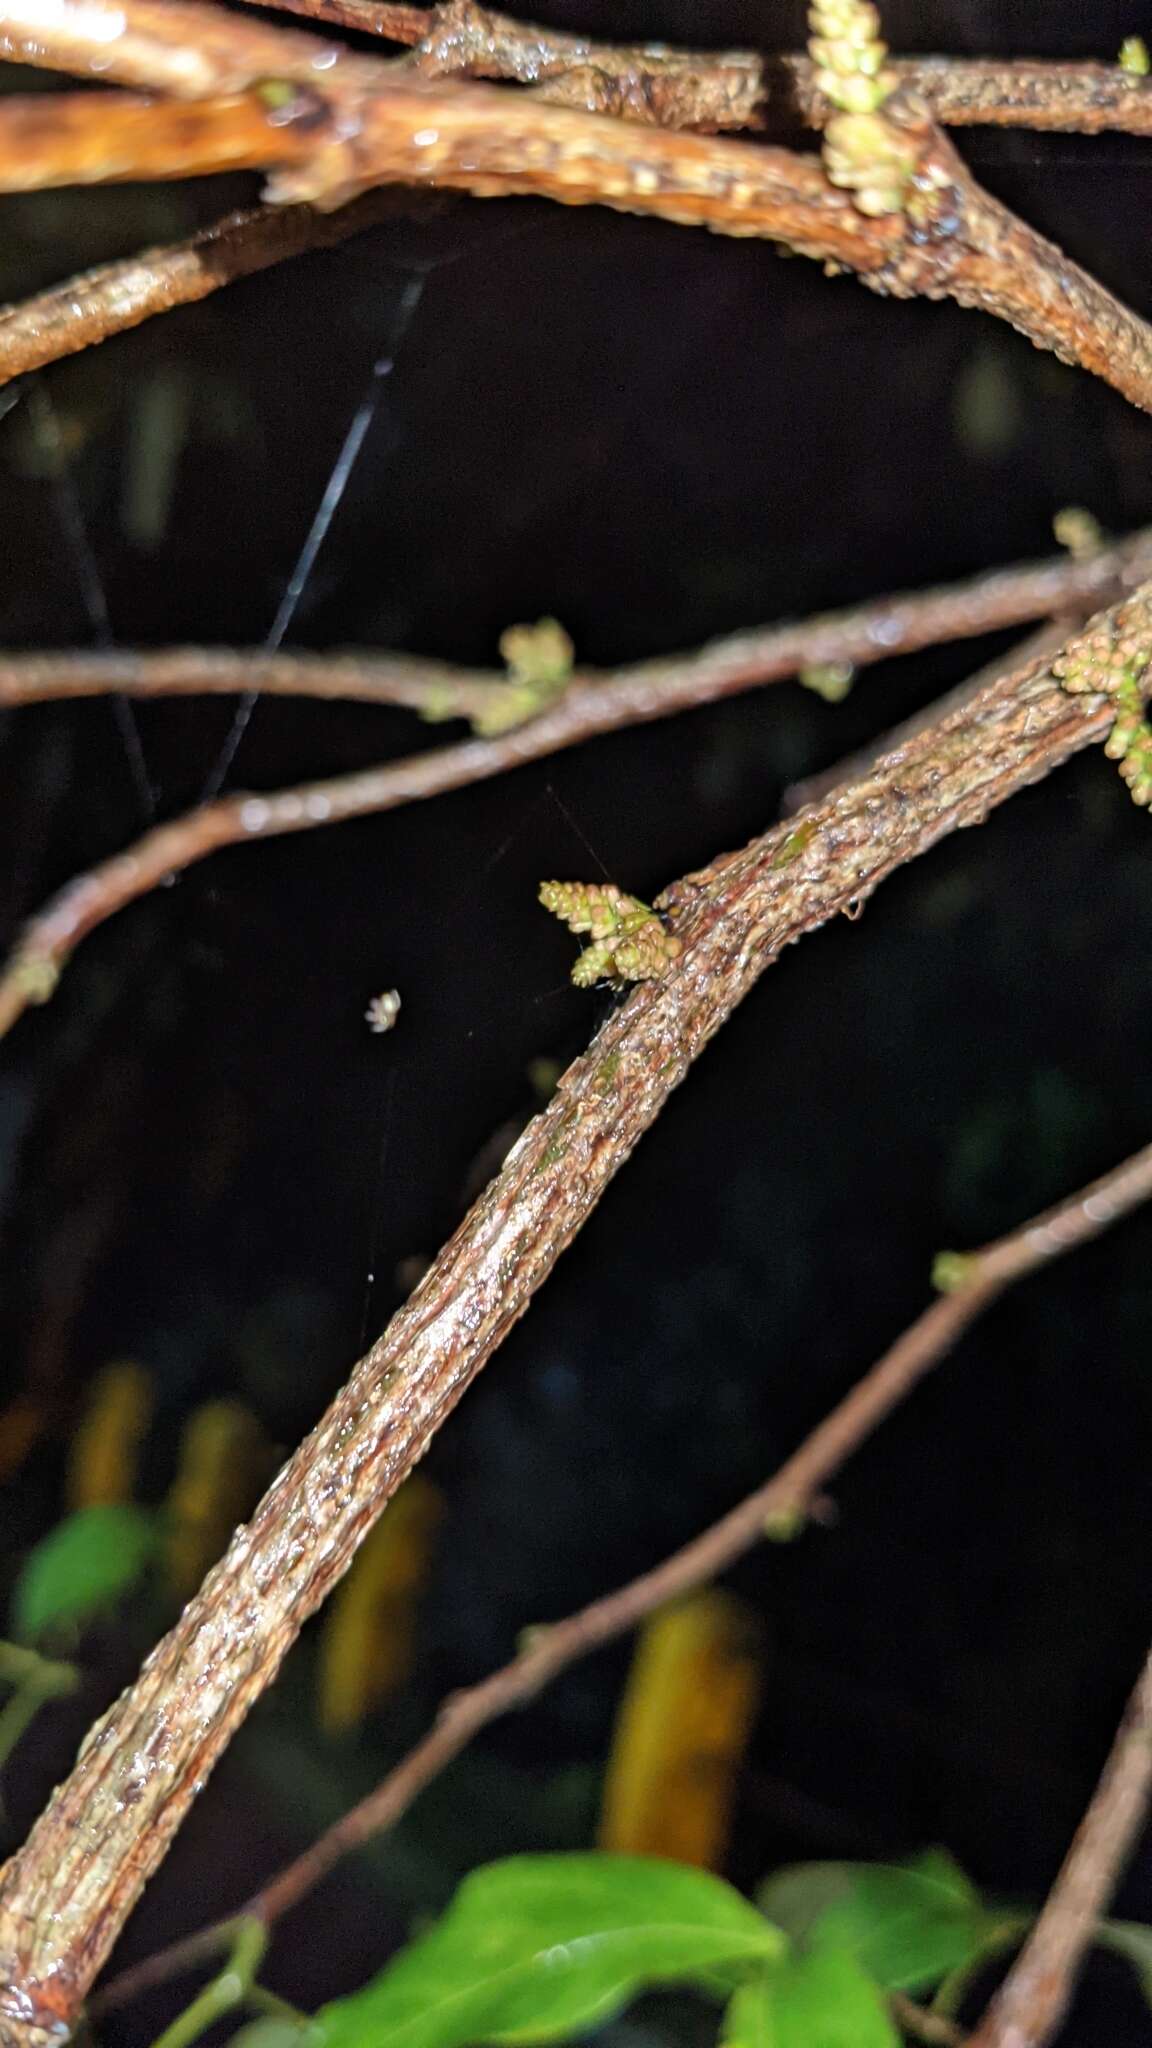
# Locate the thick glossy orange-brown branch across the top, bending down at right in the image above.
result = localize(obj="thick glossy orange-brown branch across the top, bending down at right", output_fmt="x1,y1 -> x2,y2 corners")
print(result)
0,0 -> 1152,410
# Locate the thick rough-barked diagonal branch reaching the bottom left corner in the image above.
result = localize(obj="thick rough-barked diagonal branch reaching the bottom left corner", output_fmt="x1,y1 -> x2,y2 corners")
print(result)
0,588 -> 1152,2048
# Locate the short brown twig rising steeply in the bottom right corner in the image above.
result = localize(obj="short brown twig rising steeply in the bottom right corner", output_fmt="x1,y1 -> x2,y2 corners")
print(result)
970,1651 -> 1152,2048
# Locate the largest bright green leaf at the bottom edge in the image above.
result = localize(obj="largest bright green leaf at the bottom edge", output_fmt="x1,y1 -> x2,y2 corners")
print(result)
316,1855 -> 783,2048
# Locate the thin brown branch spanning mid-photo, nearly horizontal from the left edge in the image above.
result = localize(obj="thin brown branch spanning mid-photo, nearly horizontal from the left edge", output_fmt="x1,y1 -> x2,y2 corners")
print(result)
0,530 -> 1152,708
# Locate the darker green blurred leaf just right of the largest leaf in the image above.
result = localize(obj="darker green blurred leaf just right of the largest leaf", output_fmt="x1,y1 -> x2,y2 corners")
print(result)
756,1849 -> 996,1991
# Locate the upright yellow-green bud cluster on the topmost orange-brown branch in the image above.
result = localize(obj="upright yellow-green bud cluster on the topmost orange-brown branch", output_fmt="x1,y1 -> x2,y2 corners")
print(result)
808,0 -> 916,215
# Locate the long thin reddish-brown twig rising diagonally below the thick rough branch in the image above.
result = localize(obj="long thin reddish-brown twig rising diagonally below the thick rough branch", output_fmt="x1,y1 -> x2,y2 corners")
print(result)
94,1145 -> 1152,2015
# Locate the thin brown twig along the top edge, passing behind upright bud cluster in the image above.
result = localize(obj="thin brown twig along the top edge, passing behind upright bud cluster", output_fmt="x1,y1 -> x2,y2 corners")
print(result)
233,0 -> 1152,135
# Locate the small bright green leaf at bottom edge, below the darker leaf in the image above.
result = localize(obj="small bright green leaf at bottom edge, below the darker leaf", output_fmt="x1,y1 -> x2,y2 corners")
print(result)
719,1948 -> 900,2048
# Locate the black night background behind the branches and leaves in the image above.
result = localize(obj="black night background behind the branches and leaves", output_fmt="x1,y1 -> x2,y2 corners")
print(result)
0,0 -> 1152,2048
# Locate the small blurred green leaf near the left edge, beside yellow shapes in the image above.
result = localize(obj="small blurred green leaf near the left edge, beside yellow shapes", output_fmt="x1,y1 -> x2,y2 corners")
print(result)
12,1507 -> 156,1642
